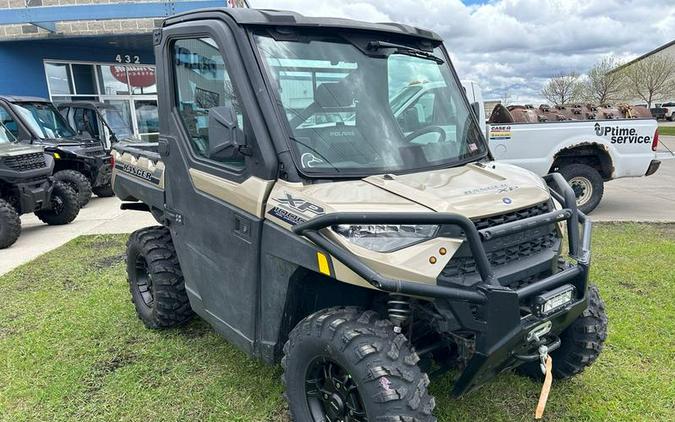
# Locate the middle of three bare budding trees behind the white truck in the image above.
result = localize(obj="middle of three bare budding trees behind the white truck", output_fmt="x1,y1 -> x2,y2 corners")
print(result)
584,57 -> 625,105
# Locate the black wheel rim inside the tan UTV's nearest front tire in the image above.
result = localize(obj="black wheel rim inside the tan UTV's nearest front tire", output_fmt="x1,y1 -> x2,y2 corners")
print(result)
305,357 -> 368,422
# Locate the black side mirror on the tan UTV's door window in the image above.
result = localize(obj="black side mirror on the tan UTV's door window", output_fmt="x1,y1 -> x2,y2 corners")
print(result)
207,102 -> 244,160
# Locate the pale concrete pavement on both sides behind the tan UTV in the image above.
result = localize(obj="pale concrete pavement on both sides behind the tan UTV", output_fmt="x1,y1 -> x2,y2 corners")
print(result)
0,136 -> 675,275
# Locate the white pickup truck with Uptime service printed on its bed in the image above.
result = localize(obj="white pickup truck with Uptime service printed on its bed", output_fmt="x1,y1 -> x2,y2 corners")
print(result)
462,81 -> 672,213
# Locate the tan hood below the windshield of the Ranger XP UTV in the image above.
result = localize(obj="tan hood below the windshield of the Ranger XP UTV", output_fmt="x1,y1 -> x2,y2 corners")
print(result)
268,162 -> 549,219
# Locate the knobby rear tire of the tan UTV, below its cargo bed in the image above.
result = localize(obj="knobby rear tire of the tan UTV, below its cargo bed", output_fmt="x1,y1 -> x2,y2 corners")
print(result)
127,226 -> 193,329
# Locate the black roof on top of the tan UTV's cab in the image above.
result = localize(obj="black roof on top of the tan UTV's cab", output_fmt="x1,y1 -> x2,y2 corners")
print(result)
164,8 -> 442,41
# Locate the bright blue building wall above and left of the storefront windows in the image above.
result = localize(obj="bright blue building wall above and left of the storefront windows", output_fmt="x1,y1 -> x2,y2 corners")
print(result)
0,38 -> 155,98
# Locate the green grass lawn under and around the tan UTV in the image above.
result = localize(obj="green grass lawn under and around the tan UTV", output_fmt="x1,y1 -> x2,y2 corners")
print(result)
0,224 -> 675,421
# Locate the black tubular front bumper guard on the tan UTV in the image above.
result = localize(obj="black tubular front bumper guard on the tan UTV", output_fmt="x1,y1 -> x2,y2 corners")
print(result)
293,173 -> 591,395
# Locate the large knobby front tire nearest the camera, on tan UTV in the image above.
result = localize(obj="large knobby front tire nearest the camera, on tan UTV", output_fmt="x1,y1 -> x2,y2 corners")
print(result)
281,308 -> 436,422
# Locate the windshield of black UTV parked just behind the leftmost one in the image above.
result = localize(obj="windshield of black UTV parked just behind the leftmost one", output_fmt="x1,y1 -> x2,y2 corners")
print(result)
13,103 -> 76,139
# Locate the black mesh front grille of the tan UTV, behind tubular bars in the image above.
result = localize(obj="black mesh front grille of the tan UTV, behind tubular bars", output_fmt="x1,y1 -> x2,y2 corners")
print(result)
439,202 -> 558,280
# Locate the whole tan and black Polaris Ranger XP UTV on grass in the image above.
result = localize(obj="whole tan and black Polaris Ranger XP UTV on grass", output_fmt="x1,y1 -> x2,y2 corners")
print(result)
113,9 -> 607,422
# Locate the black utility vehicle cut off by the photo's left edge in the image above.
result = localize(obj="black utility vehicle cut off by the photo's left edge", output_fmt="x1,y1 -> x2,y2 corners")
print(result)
0,124 -> 80,249
